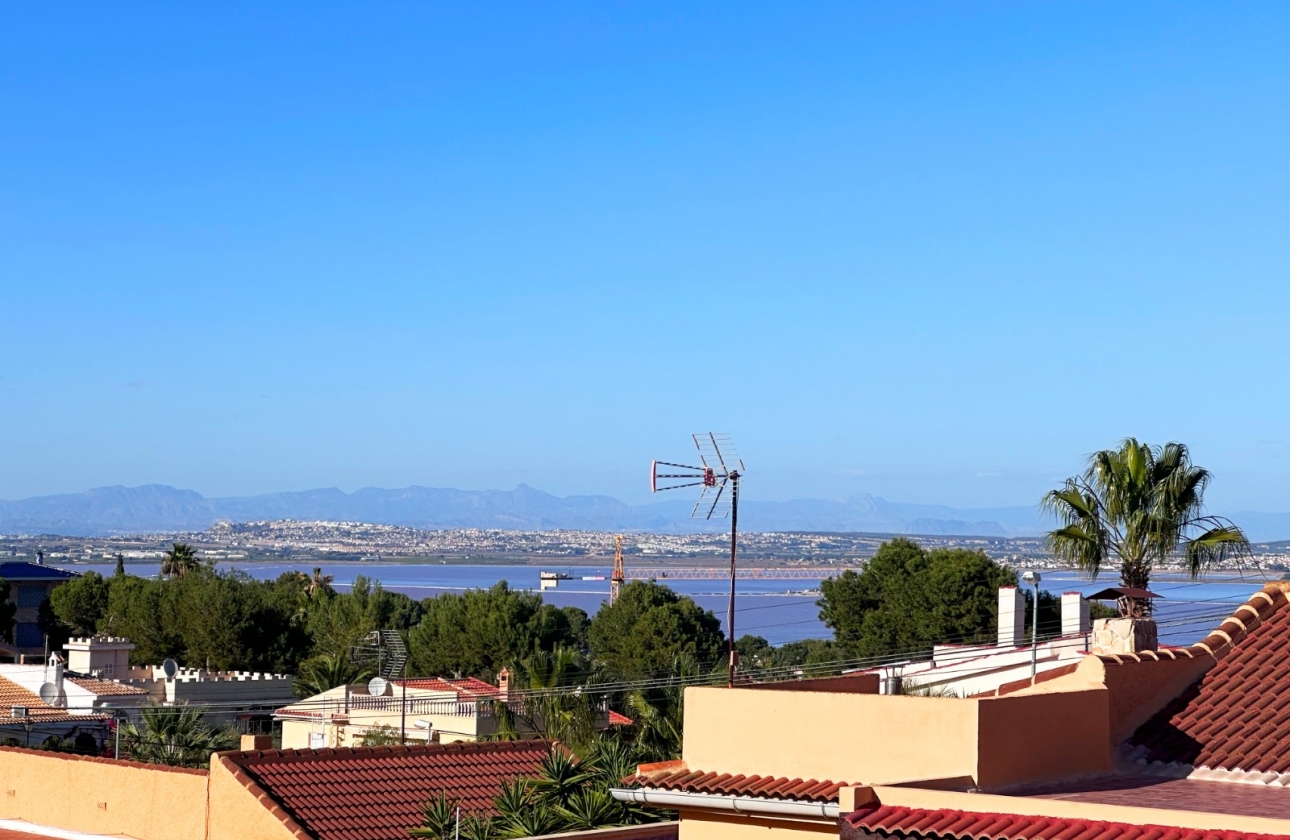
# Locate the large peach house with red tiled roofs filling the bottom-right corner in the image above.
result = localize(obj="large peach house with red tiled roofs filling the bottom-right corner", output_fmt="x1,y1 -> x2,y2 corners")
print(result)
614,583 -> 1290,840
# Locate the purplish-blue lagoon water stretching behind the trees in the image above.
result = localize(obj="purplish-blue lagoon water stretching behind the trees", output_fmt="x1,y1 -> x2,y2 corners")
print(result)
72,563 -> 1279,645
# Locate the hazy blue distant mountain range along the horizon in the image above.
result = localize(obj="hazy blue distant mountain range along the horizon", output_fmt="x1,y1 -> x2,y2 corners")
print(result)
0,484 -> 1290,542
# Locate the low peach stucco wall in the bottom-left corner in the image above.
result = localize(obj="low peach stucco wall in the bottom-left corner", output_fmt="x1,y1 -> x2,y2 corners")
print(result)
0,748 -> 206,840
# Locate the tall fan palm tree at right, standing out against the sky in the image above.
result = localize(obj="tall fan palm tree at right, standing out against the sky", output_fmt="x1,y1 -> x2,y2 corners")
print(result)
1042,437 -> 1250,615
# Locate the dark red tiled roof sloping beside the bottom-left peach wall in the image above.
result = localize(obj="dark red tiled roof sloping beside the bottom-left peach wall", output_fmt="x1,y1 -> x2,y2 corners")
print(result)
219,741 -> 552,840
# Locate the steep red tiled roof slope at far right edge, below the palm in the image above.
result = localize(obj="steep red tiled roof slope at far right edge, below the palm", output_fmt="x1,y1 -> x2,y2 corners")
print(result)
1129,583 -> 1290,773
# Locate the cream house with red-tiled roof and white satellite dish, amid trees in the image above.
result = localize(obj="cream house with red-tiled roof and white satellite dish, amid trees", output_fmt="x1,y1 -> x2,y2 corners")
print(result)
273,668 -> 611,750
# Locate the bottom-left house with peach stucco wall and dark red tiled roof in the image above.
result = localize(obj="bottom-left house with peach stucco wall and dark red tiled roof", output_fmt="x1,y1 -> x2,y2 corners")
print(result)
0,735 -> 676,840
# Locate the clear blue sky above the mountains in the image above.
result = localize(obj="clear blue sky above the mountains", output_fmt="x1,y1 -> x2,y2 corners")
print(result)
0,3 -> 1290,510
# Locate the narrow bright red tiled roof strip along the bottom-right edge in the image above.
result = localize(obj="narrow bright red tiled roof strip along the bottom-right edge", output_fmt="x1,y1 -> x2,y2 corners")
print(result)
842,805 -> 1286,840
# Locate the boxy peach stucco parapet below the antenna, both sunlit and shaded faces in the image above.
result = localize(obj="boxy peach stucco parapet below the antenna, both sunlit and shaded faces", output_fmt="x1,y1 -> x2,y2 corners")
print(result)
682,688 -> 1112,789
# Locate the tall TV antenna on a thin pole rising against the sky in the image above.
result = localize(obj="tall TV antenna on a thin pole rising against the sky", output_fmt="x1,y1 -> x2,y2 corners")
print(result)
649,432 -> 743,688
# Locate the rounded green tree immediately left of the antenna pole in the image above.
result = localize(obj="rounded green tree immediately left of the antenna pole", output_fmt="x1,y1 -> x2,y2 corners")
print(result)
587,581 -> 725,679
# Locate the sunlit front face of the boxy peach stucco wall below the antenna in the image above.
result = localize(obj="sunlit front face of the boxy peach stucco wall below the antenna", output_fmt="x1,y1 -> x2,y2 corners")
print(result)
682,688 -> 977,784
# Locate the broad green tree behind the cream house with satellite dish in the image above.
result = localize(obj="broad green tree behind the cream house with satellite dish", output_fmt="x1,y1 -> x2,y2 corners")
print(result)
408,581 -> 575,679
